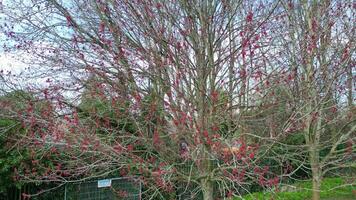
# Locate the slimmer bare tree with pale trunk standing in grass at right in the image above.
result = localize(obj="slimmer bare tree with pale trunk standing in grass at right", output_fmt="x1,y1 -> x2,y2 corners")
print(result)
281,1 -> 356,200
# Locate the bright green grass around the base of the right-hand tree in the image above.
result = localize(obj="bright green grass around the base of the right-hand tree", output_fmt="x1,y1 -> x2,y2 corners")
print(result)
236,178 -> 356,200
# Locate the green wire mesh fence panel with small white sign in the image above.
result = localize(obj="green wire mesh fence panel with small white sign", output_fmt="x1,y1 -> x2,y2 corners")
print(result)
64,177 -> 142,200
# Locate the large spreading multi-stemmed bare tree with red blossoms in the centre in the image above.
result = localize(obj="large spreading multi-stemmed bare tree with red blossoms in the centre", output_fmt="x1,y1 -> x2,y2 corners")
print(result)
0,0 -> 286,199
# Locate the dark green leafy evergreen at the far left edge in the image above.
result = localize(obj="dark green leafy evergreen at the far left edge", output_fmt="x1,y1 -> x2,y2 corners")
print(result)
0,91 -> 45,199
